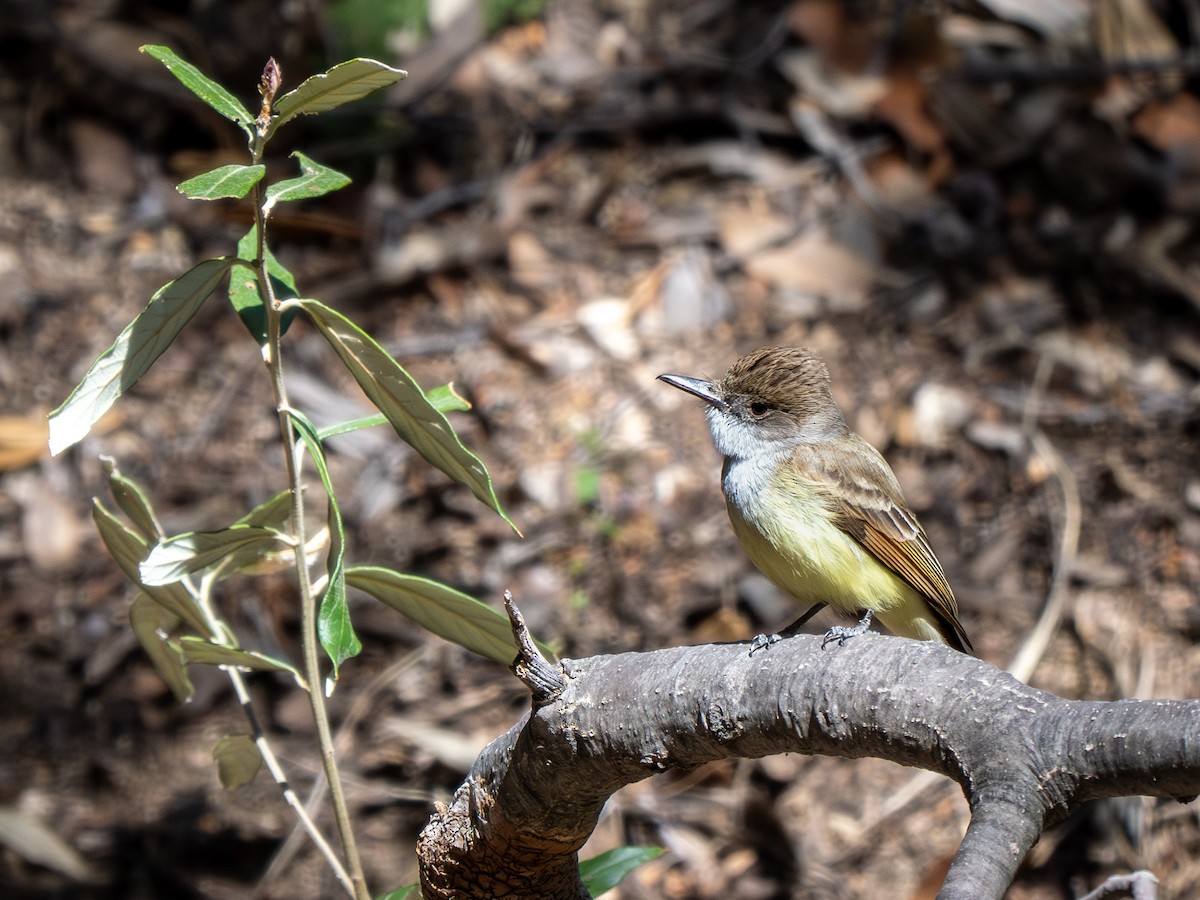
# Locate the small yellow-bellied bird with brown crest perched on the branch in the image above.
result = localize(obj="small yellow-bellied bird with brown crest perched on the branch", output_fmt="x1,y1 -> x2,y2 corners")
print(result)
659,347 -> 971,652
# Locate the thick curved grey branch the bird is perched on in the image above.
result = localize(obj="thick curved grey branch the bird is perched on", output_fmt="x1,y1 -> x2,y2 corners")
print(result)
418,619 -> 1200,900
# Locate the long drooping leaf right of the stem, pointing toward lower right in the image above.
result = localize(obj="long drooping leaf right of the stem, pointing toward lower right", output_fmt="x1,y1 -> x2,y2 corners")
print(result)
293,299 -> 521,534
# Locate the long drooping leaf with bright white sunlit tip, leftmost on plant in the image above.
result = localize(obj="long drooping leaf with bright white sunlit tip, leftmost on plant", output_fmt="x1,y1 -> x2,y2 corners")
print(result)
50,258 -> 235,454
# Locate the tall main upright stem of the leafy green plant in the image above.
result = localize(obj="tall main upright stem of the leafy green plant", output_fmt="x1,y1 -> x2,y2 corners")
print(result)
253,146 -> 371,900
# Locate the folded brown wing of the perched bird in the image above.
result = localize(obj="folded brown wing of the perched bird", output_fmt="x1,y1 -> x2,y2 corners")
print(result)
798,434 -> 971,650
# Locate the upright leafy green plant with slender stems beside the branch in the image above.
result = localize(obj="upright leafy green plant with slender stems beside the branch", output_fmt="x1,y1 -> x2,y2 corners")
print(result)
50,46 -> 525,899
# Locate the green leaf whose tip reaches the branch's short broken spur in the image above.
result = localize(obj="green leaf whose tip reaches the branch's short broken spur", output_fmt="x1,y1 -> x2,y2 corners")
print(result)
346,565 -> 528,666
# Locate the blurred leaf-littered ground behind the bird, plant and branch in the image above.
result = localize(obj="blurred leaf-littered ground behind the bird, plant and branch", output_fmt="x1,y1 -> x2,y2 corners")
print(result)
0,0 -> 1200,900
